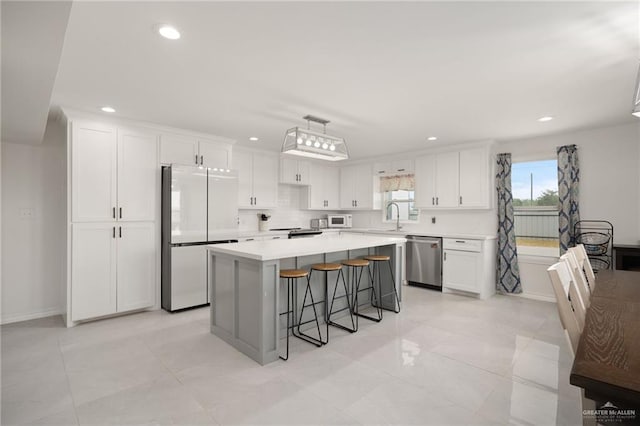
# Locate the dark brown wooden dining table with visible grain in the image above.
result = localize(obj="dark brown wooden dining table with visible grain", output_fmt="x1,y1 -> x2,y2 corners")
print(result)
569,270 -> 640,408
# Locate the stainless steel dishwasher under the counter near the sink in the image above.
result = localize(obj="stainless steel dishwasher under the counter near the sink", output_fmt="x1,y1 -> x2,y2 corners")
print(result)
407,235 -> 442,291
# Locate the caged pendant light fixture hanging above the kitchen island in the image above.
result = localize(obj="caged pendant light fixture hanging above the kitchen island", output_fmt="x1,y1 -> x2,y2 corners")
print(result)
282,115 -> 349,161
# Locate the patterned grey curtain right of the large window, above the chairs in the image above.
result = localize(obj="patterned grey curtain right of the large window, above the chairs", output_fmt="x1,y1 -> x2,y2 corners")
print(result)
558,145 -> 580,255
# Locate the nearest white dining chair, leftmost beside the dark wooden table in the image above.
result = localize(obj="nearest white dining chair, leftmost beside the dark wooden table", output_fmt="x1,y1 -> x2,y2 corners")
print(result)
547,262 -> 585,354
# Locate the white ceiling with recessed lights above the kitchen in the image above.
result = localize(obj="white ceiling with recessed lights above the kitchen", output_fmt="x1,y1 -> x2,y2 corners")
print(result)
3,1 -> 640,158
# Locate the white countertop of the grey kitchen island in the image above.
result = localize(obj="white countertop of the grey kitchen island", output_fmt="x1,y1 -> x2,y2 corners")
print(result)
206,234 -> 406,261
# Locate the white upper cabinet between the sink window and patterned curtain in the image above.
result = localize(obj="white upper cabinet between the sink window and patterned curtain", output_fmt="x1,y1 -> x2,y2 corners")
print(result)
415,147 -> 490,209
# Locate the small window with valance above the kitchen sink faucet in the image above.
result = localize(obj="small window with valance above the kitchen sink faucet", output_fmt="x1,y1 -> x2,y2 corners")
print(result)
380,174 -> 420,222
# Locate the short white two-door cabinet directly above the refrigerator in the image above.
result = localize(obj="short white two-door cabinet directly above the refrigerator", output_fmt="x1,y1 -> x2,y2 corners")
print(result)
160,134 -> 232,169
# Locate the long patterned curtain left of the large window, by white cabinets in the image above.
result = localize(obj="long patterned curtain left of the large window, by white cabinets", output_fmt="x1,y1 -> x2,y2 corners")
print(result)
496,154 -> 522,293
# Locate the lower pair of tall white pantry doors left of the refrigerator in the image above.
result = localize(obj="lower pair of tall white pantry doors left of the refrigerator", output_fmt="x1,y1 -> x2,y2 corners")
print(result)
71,222 -> 156,321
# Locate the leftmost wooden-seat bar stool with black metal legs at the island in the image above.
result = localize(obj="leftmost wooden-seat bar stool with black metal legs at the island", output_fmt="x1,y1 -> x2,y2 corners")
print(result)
280,269 -> 322,361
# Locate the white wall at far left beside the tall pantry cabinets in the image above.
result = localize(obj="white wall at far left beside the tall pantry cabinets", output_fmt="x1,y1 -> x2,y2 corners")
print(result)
0,116 -> 66,323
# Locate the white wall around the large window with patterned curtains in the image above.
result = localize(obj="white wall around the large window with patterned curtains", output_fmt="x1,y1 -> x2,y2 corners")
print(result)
497,122 -> 640,300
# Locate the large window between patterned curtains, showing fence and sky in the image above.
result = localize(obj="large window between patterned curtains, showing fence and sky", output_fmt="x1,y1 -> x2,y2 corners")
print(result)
511,159 -> 559,256
